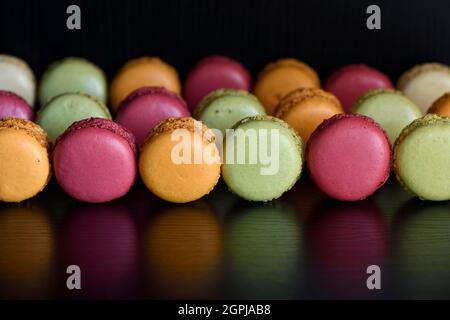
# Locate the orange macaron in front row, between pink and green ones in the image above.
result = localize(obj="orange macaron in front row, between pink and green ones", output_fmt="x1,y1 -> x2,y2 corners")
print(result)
139,130 -> 220,203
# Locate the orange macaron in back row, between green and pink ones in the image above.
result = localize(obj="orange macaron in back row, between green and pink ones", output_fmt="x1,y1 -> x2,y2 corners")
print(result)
110,57 -> 181,111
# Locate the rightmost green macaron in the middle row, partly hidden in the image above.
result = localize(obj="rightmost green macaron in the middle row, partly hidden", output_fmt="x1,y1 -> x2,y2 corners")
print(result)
352,89 -> 422,145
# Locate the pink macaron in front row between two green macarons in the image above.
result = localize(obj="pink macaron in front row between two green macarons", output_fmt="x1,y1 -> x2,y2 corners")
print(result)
307,114 -> 391,201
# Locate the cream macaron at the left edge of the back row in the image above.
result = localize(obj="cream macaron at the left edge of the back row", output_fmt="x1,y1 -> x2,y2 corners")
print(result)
0,54 -> 36,107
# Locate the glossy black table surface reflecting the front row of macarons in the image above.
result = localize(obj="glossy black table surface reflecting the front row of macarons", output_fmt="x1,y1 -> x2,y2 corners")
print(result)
0,174 -> 450,299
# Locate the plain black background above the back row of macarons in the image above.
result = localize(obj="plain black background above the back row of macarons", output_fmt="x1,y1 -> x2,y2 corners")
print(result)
0,0 -> 450,81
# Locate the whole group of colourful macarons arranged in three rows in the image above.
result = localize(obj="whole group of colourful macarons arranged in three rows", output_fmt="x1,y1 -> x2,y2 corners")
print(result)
0,55 -> 450,203
